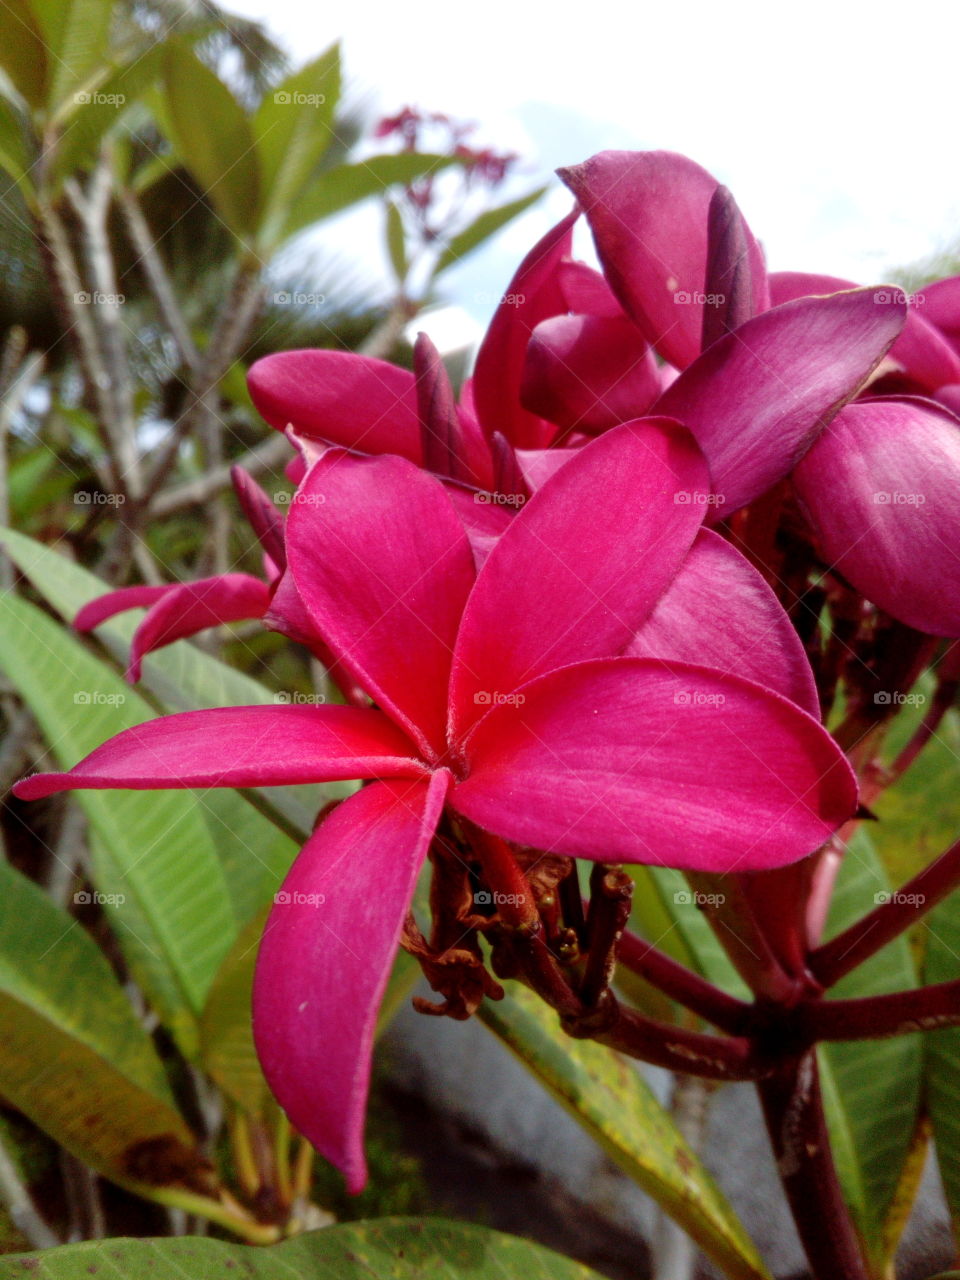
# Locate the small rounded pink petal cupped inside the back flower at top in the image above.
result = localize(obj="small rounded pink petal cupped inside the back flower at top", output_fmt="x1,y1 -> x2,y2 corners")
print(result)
521,315 -> 660,433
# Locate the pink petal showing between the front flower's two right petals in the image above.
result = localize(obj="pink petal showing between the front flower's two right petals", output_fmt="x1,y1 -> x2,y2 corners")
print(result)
625,529 -> 820,719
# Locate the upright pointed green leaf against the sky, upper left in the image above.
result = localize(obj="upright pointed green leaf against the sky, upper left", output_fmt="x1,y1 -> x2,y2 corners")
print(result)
252,45 -> 340,243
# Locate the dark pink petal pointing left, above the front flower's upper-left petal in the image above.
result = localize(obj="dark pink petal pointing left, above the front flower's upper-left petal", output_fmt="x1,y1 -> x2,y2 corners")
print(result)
247,351 -> 422,463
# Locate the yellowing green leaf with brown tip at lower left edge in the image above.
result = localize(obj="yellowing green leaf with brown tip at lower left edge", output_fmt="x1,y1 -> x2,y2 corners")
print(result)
0,863 -> 200,1183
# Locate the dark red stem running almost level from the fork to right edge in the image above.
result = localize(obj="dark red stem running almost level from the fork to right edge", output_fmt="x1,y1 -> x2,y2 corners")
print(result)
796,979 -> 960,1041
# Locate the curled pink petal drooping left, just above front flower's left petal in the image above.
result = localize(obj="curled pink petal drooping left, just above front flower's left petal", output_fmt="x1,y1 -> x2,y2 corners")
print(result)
127,573 -> 270,684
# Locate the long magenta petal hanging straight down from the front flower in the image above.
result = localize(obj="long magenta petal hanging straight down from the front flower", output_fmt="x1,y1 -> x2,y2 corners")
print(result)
253,771 -> 449,1193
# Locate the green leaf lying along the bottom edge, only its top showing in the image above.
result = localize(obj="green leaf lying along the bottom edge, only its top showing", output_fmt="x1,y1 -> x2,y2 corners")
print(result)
0,1217 -> 602,1280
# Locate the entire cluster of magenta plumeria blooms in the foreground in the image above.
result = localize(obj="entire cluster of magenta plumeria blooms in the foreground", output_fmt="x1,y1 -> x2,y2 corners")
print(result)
18,152 -> 960,1190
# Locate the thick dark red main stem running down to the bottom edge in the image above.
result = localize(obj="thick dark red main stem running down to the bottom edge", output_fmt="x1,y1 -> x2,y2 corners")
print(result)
756,1050 -> 869,1280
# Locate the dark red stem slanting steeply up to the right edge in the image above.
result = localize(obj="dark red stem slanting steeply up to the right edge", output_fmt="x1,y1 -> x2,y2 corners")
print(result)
809,840 -> 960,987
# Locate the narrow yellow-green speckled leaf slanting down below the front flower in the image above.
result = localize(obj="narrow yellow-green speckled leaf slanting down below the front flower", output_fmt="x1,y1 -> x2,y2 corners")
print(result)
479,983 -> 769,1280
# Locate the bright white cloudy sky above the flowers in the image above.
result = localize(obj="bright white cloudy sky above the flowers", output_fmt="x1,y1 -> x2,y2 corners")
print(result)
227,0 -> 960,325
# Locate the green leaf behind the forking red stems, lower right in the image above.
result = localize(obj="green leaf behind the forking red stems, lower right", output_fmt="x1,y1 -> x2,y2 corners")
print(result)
819,829 -> 922,1275
